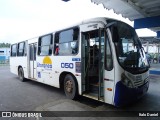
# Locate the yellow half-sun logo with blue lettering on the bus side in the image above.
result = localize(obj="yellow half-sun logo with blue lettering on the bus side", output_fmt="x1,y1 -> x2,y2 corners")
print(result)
37,56 -> 52,69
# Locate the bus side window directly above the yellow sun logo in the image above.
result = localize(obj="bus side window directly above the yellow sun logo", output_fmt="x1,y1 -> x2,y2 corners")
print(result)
38,34 -> 52,56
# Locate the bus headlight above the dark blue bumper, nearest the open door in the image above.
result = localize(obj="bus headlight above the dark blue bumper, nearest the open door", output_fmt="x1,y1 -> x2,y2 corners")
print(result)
121,73 -> 133,88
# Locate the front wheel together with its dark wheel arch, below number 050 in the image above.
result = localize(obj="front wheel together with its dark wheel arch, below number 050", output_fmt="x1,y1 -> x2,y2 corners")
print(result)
59,72 -> 79,99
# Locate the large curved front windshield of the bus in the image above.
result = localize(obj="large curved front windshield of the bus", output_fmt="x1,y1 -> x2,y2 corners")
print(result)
109,22 -> 149,74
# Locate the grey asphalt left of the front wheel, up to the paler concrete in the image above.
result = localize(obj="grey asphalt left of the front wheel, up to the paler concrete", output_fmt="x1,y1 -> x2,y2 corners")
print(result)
0,67 -> 65,111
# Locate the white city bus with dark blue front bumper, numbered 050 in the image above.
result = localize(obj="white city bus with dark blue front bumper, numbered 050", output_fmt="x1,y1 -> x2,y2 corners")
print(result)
10,18 -> 149,106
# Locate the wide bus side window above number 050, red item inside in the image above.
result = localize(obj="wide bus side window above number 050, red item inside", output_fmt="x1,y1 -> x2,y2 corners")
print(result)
54,28 -> 79,56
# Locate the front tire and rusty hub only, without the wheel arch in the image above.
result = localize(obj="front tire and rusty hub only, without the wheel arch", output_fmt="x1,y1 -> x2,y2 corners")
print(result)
64,74 -> 78,100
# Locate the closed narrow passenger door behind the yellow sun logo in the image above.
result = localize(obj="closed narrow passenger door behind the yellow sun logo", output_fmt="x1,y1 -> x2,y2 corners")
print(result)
29,44 -> 37,79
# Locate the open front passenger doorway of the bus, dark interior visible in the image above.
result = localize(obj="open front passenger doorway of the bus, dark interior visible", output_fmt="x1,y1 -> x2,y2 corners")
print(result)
82,28 -> 104,101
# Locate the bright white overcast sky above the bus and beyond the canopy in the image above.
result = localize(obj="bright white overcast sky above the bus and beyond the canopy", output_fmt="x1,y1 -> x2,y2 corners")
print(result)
0,0 -> 156,43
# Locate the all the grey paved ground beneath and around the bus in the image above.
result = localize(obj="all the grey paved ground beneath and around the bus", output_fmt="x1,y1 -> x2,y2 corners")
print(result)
0,67 -> 160,120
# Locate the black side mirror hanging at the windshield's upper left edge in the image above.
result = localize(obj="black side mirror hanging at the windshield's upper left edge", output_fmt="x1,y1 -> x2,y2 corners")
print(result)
111,25 -> 119,42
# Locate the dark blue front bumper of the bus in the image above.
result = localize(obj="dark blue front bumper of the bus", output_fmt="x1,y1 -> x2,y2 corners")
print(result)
114,81 -> 149,107
